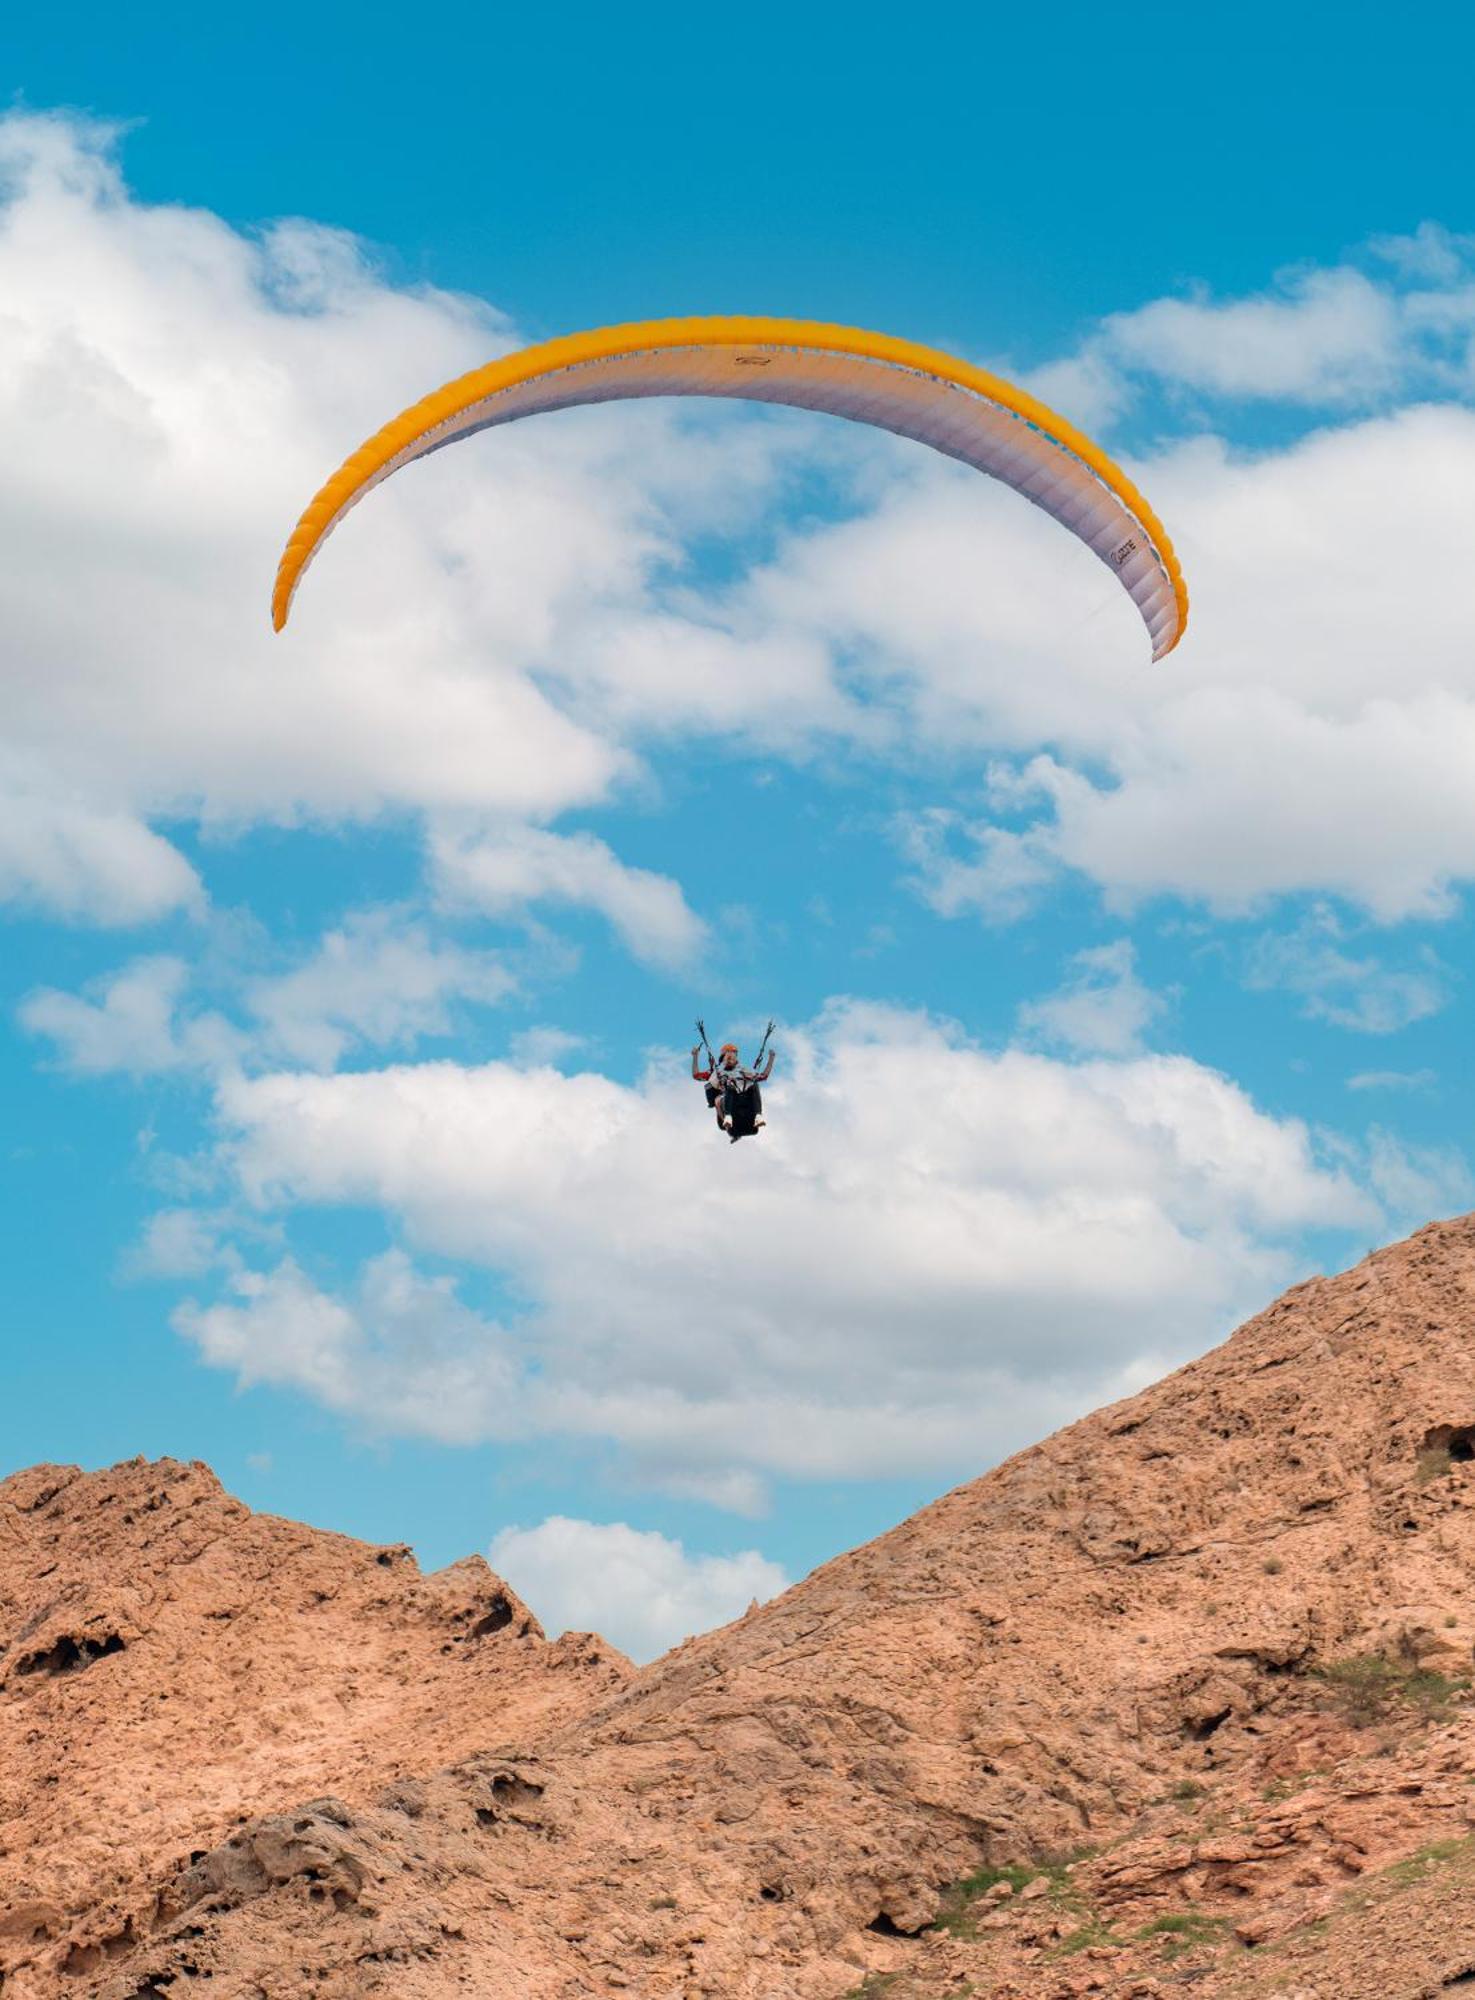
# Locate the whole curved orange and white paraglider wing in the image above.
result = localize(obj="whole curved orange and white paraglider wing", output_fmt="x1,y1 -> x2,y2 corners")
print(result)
272,318 -> 1187,660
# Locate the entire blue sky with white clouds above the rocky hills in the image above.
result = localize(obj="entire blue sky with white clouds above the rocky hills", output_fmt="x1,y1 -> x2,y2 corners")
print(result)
0,8 -> 1475,1650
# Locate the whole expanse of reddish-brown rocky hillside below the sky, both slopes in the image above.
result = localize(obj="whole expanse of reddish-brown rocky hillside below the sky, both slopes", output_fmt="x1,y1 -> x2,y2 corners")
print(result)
11,1218 -> 1475,2000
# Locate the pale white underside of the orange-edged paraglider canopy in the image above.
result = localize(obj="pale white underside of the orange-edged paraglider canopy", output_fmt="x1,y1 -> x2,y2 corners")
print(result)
339,344 -> 1179,660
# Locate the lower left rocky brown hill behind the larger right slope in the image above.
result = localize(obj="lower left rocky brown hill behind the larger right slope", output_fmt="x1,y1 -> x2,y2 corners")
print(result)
0,1460 -> 632,2000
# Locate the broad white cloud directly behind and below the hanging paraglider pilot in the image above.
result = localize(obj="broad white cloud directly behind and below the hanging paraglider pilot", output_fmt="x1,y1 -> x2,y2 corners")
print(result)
174,1006 -> 1377,1508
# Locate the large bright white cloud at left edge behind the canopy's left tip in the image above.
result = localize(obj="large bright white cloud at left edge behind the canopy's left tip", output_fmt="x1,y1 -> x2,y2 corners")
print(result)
0,112 -> 835,944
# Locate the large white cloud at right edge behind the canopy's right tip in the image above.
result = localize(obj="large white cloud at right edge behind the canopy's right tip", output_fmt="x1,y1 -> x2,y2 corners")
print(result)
775,406 -> 1475,922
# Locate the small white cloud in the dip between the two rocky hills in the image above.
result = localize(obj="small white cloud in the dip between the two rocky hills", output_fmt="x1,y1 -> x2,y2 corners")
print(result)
488,1514 -> 789,1662
